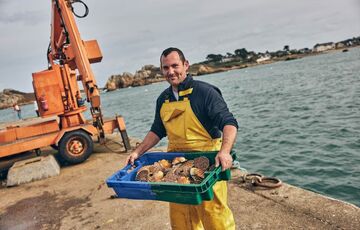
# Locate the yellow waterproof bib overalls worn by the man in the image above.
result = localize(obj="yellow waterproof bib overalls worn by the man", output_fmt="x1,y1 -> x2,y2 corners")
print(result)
160,88 -> 235,230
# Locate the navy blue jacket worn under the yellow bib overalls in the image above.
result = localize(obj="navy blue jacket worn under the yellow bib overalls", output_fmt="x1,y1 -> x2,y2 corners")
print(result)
150,75 -> 238,139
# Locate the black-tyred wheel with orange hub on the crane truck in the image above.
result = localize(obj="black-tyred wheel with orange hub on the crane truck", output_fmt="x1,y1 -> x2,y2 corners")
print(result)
59,130 -> 94,164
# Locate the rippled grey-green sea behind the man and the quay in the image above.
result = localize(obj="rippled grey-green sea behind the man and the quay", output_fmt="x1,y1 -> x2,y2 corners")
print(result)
0,48 -> 360,206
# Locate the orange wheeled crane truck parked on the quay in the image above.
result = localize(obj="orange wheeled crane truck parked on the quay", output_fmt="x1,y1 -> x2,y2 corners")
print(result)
0,0 -> 130,170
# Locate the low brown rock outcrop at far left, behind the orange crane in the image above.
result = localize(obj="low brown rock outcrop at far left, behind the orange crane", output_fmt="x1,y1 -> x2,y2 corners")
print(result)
0,89 -> 35,109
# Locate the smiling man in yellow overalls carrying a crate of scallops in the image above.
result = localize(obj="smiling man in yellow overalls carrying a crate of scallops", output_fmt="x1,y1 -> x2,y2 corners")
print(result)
126,47 -> 238,229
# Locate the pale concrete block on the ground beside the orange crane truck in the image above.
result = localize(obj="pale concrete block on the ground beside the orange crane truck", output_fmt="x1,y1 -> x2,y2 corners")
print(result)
6,155 -> 60,186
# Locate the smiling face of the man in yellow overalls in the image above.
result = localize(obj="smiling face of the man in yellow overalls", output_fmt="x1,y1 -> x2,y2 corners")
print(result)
161,51 -> 189,89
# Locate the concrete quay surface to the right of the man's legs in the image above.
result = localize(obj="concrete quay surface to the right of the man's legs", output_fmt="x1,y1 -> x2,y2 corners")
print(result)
228,170 -> 360,229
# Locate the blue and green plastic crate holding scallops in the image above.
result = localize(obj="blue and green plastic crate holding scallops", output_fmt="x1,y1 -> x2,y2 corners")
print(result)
106,152 -> 235,204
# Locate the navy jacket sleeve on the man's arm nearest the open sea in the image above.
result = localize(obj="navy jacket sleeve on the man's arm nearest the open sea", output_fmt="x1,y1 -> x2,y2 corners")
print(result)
204,87 -> 239,131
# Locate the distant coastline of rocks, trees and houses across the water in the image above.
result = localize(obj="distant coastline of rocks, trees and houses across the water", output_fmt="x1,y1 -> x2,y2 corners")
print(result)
0,36 -> 360,109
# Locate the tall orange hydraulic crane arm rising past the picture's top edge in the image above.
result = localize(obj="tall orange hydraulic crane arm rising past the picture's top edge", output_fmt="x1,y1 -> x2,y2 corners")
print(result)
48,0 -> 104,140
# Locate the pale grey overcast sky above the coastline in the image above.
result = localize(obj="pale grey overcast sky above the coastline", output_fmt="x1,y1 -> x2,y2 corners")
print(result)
0,0 -> 360,92
